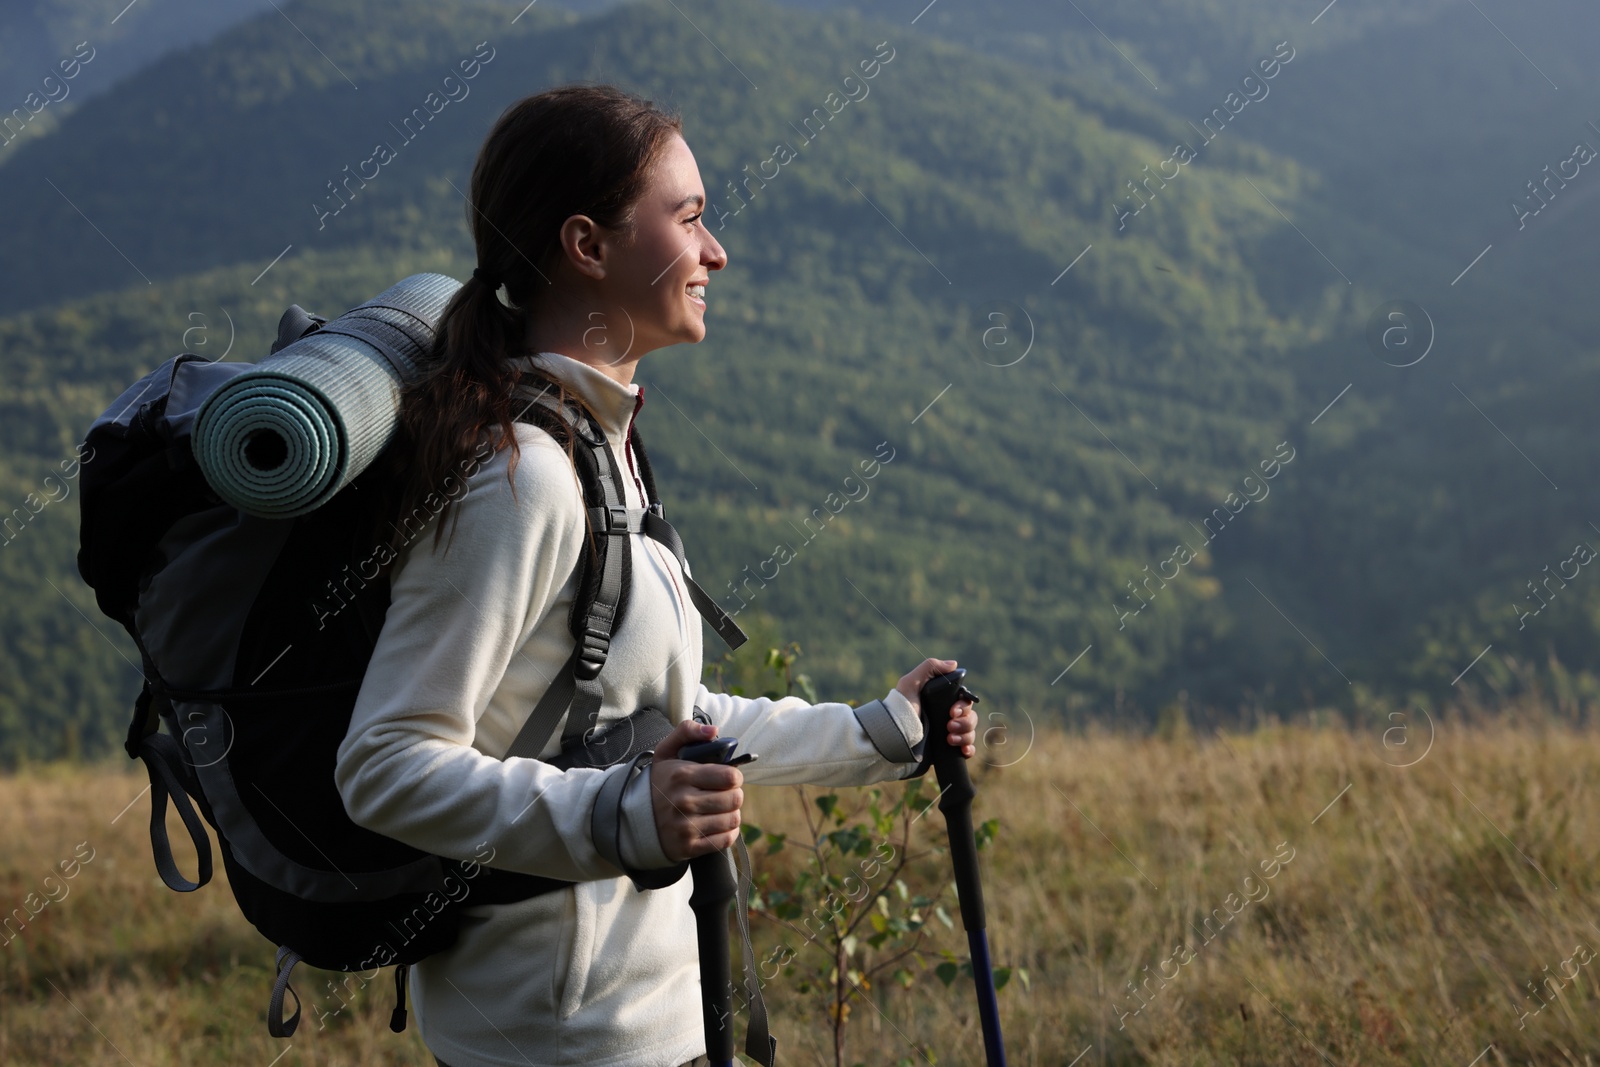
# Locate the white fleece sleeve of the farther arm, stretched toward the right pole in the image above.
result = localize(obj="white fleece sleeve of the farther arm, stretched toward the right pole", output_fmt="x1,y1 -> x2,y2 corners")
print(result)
694,685 -> 926,785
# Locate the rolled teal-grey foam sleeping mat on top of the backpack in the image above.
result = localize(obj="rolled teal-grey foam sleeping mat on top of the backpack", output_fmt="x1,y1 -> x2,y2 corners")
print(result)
192,274 -> 461,518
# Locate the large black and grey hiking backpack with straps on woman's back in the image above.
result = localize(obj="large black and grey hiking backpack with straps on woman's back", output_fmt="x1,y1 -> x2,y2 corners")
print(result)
77,275 -> 746,1037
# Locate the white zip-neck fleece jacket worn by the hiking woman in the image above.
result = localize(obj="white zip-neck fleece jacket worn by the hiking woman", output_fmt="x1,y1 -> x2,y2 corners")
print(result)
336,352 -> 922,1067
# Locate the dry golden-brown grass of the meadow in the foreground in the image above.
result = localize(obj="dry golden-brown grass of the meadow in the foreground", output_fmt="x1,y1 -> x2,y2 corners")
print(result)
0,723 -> 1600,1067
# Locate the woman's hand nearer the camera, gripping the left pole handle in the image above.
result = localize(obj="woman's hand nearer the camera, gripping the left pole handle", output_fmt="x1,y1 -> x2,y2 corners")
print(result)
648,718 -> 744,864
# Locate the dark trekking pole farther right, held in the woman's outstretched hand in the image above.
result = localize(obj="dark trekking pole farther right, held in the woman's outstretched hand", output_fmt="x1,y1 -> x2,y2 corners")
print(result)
920,667 -> 1005,1067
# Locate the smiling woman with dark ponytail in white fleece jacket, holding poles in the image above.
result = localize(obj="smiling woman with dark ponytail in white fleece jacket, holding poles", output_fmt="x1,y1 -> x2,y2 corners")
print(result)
336,86 -> 976,1067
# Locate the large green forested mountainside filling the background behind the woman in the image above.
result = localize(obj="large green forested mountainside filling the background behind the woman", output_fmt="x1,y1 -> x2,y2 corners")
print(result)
0,0 -> 1600,758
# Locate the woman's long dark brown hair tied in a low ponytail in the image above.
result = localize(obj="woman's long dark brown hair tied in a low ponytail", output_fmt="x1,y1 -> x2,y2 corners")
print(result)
377,85 -> 683,552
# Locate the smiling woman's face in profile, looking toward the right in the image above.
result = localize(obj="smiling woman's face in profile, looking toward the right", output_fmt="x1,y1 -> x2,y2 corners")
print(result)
605,134 -> 728,357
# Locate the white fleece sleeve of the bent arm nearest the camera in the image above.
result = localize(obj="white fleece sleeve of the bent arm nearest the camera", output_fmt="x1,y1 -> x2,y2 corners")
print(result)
334,424 -> 646,881
